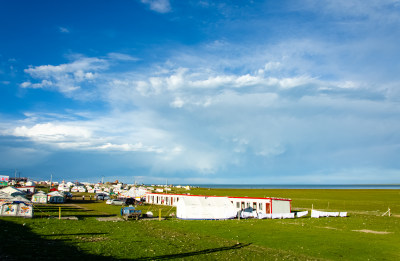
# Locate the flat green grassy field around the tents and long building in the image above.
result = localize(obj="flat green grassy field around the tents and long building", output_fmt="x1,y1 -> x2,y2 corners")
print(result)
0,189 -> 400,260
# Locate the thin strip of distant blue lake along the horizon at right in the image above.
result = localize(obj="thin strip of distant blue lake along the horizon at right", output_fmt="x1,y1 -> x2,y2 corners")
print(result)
190,184 -> 400,189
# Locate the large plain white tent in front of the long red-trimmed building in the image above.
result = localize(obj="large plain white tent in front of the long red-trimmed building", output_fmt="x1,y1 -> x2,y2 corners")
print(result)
176,196 -> 237,219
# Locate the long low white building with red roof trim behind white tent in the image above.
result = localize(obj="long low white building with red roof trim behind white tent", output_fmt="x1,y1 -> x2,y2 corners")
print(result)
146,193 -> 292,214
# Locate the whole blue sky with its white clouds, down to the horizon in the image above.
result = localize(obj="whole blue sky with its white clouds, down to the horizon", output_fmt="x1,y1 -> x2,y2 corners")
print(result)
0,0 -> 400,184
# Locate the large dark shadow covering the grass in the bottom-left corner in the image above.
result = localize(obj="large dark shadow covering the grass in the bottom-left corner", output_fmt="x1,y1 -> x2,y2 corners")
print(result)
0,219 -> 116,261
